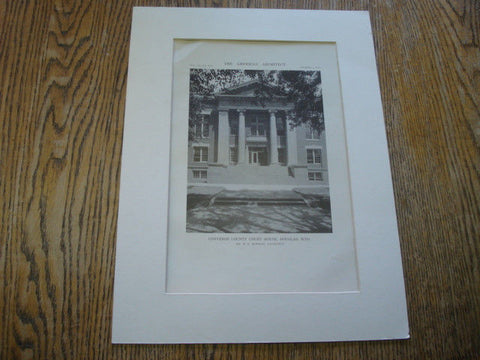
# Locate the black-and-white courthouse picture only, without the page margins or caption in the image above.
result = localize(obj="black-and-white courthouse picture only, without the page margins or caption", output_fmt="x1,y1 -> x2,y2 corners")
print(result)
186,68 -> 332,233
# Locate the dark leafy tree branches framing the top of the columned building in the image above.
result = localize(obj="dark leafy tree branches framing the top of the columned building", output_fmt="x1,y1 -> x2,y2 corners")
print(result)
189,69 -> 325,136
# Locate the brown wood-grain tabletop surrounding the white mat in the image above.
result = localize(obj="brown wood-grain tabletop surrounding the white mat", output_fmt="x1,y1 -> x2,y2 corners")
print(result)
0,0 -> 480,359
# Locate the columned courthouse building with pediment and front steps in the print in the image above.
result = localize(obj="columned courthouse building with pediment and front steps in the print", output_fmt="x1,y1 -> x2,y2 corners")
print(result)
188,80 -> 328,186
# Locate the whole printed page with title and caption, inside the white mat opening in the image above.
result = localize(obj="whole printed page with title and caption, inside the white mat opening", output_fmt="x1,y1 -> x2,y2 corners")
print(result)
167,40 -> 357,293
